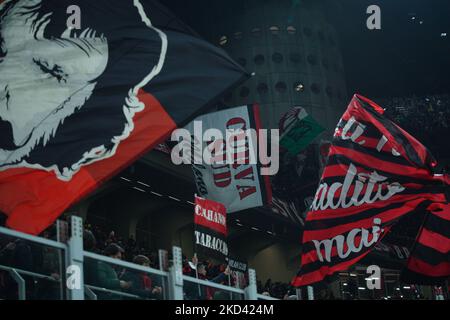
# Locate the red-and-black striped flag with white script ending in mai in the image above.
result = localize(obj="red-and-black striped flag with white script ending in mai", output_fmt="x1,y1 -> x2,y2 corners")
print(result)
293,95 -> 450,286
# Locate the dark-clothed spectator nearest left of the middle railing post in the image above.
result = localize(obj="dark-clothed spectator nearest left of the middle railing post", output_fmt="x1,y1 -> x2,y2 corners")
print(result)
121,255 -> 162,299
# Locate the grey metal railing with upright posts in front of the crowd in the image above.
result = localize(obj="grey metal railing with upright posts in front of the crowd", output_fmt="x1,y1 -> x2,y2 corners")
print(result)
0,216 -> 276,300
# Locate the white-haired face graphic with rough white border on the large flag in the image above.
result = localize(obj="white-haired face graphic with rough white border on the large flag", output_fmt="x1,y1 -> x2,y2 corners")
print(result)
0,0 -> 167,180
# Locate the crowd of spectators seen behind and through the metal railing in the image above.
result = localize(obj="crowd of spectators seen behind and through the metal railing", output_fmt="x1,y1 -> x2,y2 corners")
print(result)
0,218 -> 332,300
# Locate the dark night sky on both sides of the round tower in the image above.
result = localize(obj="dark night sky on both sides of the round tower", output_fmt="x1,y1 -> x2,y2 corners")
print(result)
161,0 -> 450,97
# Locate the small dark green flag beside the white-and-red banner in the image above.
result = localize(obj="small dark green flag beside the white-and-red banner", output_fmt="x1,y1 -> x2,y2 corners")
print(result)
280,107 -> 325,155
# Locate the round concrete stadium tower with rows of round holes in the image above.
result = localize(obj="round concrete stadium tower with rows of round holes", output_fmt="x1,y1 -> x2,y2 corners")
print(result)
200,0 -> 347,131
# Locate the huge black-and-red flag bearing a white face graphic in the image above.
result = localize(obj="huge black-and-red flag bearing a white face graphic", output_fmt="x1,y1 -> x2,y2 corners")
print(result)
0,0 -> 248,234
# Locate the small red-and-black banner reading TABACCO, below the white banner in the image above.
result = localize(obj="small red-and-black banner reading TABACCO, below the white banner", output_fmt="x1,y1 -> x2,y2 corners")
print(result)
194,196 -> 228,260
